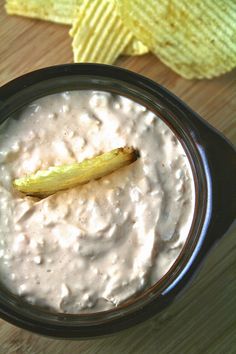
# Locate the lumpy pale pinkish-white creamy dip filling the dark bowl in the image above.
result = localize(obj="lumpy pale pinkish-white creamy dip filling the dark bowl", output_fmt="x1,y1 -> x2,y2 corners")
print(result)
0,91 -> 195,313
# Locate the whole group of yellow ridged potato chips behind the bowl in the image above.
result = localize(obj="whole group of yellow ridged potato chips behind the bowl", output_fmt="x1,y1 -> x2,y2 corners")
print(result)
6,0 -> 236,79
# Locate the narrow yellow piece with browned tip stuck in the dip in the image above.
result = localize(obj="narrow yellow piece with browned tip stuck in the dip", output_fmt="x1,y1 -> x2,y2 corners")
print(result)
13,147 -> 138,197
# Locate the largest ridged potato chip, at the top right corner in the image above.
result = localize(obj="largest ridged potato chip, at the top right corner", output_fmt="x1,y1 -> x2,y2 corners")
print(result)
117,0 -> 236,79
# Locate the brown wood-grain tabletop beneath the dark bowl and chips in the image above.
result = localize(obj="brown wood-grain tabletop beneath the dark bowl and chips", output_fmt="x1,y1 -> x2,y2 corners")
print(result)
0,0 -> 236,354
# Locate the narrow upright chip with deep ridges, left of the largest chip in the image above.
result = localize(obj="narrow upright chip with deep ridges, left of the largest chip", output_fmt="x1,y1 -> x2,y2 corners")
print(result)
70,0 -> 133,64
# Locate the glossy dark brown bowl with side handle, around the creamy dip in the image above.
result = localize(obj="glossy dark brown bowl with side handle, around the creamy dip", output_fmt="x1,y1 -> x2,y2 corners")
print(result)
0,64 -> 236,338
